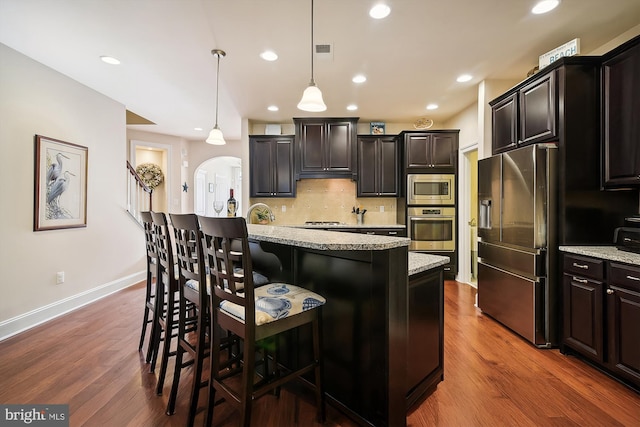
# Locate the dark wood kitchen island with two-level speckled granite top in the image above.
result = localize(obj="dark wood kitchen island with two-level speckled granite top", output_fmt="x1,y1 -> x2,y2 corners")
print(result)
248,225 -> 448,427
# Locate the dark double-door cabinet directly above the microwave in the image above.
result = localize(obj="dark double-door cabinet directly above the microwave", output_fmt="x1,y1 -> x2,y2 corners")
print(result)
401,131 -> 458,172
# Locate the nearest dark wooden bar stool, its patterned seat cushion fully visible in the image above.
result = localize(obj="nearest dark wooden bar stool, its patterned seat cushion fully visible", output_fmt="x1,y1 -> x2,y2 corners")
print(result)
198,216 -> 325,426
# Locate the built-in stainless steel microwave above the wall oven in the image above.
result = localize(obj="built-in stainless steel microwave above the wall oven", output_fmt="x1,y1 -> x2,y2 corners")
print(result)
407,174 -> 456,206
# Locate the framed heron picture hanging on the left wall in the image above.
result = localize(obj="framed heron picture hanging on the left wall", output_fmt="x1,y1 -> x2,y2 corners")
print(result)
33,135 -> 88,231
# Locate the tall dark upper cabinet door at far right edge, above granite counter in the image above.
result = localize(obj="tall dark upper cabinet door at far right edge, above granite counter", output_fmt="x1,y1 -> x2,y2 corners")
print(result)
602,36 -> 640,187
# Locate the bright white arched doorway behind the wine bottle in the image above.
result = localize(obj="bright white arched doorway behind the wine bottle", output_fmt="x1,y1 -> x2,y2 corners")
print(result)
193,156 -> 243,216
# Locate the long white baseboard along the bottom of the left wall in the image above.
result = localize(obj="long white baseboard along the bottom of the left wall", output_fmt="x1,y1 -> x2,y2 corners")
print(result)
0,271 -> 146,341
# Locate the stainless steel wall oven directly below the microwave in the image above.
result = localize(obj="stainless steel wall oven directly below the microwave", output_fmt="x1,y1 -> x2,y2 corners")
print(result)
407,206 -> 456,252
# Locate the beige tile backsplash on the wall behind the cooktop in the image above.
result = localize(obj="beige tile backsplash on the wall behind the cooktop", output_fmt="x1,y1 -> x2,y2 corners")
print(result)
249,179 -> 397,225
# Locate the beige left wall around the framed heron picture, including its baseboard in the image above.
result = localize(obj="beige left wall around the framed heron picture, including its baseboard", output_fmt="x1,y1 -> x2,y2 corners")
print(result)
0,44 -> 144,339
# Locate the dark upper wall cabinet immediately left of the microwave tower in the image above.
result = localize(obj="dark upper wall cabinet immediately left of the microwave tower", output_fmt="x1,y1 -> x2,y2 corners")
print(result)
357,135 -> 399,197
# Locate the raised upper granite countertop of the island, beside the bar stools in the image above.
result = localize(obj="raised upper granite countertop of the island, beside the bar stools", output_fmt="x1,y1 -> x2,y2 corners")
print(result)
247,224 -> 410,251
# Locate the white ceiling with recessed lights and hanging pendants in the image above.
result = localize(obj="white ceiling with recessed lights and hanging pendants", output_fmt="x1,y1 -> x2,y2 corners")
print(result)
0,0 -> 640,140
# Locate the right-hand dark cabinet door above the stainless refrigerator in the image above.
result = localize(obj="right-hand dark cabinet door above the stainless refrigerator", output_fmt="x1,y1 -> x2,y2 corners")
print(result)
518,73 -> 557,145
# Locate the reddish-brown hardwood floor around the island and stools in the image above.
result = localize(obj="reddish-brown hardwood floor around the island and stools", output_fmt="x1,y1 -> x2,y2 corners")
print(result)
0,281 -> 640,427
